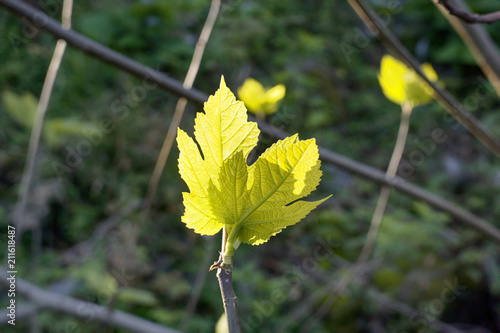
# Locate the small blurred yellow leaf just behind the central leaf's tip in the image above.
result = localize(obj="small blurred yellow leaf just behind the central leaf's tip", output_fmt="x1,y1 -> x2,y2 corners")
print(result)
238,78 -> 286,114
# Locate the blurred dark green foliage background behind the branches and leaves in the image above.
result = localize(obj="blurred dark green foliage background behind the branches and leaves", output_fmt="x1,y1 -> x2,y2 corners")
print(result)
0,0 -> 500,332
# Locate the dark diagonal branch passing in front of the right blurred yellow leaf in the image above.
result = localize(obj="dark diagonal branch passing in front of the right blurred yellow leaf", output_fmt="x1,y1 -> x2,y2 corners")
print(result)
348,0 -> 500,156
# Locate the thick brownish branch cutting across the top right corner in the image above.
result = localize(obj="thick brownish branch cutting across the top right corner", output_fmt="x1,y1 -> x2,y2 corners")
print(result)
433,0 -> 500,96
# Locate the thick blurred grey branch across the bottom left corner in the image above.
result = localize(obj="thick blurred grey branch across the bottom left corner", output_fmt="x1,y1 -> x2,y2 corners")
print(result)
0,268 -> 180,333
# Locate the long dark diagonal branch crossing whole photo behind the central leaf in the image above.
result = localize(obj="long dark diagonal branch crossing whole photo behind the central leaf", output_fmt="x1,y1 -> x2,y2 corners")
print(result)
0,0 -> 500,243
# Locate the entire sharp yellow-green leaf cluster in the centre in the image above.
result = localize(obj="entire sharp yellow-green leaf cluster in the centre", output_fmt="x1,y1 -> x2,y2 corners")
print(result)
177,79 -> 328,254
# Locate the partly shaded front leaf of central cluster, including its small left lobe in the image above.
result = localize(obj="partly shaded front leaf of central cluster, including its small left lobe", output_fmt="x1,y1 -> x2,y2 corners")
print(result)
209,135 -> 327,245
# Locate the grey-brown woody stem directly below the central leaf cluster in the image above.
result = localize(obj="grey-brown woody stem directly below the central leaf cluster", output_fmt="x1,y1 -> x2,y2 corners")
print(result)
217,265 -> 240,333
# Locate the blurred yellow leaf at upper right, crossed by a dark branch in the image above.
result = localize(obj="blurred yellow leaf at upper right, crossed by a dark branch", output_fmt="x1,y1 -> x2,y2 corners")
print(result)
378,55 -> 438,106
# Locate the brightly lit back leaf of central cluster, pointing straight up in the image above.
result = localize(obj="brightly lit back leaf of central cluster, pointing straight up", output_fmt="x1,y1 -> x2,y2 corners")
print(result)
177,78 -> 260,235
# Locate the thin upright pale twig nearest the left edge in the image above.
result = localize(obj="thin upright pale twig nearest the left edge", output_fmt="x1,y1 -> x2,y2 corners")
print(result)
14,0 -> 73,233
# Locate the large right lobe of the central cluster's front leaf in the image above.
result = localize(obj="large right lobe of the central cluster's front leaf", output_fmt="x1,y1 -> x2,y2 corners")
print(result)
238,135 -> 327,245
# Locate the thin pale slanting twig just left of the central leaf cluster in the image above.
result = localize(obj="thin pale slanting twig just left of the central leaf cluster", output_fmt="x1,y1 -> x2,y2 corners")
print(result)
142,0 -> 220,220
